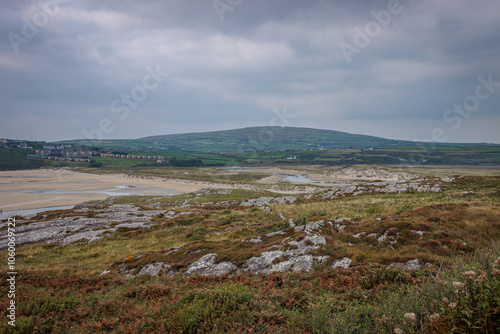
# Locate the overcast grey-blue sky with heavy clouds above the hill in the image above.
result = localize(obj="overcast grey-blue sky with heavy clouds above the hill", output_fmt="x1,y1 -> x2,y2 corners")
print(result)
0,0 -> 500,143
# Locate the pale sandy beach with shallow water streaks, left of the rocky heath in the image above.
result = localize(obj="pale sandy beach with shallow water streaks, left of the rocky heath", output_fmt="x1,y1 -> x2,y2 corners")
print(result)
0,169 -> 210,211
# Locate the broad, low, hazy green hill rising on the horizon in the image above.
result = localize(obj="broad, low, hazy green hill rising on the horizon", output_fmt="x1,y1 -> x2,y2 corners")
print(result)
65,126 -> 412,152
